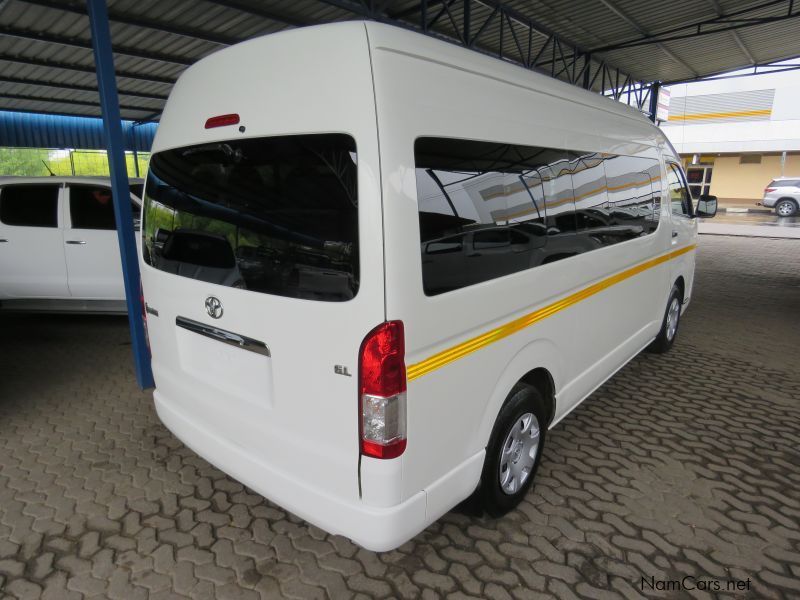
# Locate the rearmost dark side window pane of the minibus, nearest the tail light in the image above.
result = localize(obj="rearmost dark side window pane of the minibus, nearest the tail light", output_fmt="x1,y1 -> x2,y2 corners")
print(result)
414,138 -> 552,296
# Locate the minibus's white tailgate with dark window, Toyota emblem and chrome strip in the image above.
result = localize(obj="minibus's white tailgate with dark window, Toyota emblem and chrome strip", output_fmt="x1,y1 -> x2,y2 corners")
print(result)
143,134 -> 384,499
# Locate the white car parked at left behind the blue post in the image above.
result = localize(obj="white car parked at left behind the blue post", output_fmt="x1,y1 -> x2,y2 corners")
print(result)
0,176 -> 144,313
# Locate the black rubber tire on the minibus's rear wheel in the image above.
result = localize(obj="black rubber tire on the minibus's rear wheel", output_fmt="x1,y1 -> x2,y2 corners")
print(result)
476,383 -> 547,517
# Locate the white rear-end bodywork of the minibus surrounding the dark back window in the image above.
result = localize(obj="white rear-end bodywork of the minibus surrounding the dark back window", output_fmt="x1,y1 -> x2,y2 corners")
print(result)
142,23 -> 388,528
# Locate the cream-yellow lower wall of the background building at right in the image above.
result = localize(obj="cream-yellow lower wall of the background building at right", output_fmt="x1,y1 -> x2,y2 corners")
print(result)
710,154 -> 800,200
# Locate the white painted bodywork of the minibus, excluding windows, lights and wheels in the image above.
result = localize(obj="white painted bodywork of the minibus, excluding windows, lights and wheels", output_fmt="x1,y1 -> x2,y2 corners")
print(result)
142,22 -> 696,550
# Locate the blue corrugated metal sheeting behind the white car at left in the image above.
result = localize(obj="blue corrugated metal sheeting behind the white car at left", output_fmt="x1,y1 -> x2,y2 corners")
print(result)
0,111 -> 158,152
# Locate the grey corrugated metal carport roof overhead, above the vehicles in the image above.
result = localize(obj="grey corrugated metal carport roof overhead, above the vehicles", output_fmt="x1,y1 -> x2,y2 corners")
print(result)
0,0 -> 800,120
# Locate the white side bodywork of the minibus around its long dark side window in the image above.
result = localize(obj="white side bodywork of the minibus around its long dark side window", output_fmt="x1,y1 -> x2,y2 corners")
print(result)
364,23 -> 671,498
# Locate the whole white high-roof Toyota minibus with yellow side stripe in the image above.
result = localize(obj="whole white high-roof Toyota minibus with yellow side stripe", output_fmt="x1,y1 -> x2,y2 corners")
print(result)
141,22 -> 716,551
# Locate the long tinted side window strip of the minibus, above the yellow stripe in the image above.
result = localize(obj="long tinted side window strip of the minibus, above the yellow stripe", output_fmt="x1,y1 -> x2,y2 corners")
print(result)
415,138 -> 661,295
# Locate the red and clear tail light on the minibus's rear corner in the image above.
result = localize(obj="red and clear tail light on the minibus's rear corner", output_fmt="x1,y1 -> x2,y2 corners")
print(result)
358,321 -> 406,458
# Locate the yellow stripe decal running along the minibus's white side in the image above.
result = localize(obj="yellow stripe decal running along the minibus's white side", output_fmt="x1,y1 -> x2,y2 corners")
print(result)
406,244 -> 697,381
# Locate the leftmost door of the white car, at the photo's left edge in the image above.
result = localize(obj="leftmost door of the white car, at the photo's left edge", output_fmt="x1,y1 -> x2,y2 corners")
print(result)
0,183 -> 69,299
